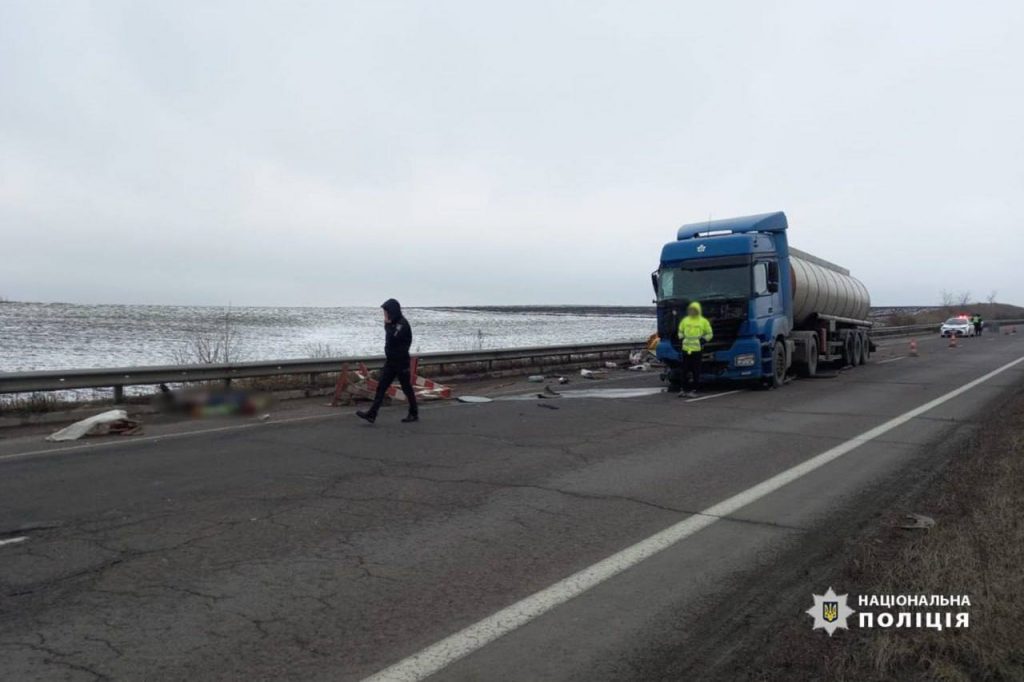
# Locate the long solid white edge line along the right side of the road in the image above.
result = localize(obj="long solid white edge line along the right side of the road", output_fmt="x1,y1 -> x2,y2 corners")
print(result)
365,357 -> 1024,682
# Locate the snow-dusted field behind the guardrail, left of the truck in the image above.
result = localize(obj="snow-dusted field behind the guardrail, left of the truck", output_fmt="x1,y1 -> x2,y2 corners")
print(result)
0,302 -> 655,372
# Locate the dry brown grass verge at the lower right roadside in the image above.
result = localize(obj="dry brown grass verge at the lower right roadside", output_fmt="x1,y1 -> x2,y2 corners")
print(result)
749,390 -> 1024,682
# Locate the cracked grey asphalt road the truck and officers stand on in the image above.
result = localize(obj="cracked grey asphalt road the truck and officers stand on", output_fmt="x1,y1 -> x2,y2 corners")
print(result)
0,335 -> 1024,680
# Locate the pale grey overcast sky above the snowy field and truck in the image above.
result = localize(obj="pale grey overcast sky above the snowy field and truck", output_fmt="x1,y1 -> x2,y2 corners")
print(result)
0,0 -> 1024,305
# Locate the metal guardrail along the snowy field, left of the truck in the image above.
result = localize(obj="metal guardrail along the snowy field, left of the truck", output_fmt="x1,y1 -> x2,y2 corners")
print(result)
0,341 -> 643,401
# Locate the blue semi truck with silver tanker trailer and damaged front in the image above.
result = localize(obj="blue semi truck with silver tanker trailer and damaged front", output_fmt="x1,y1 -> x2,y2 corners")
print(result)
651,211 -> 872,390
